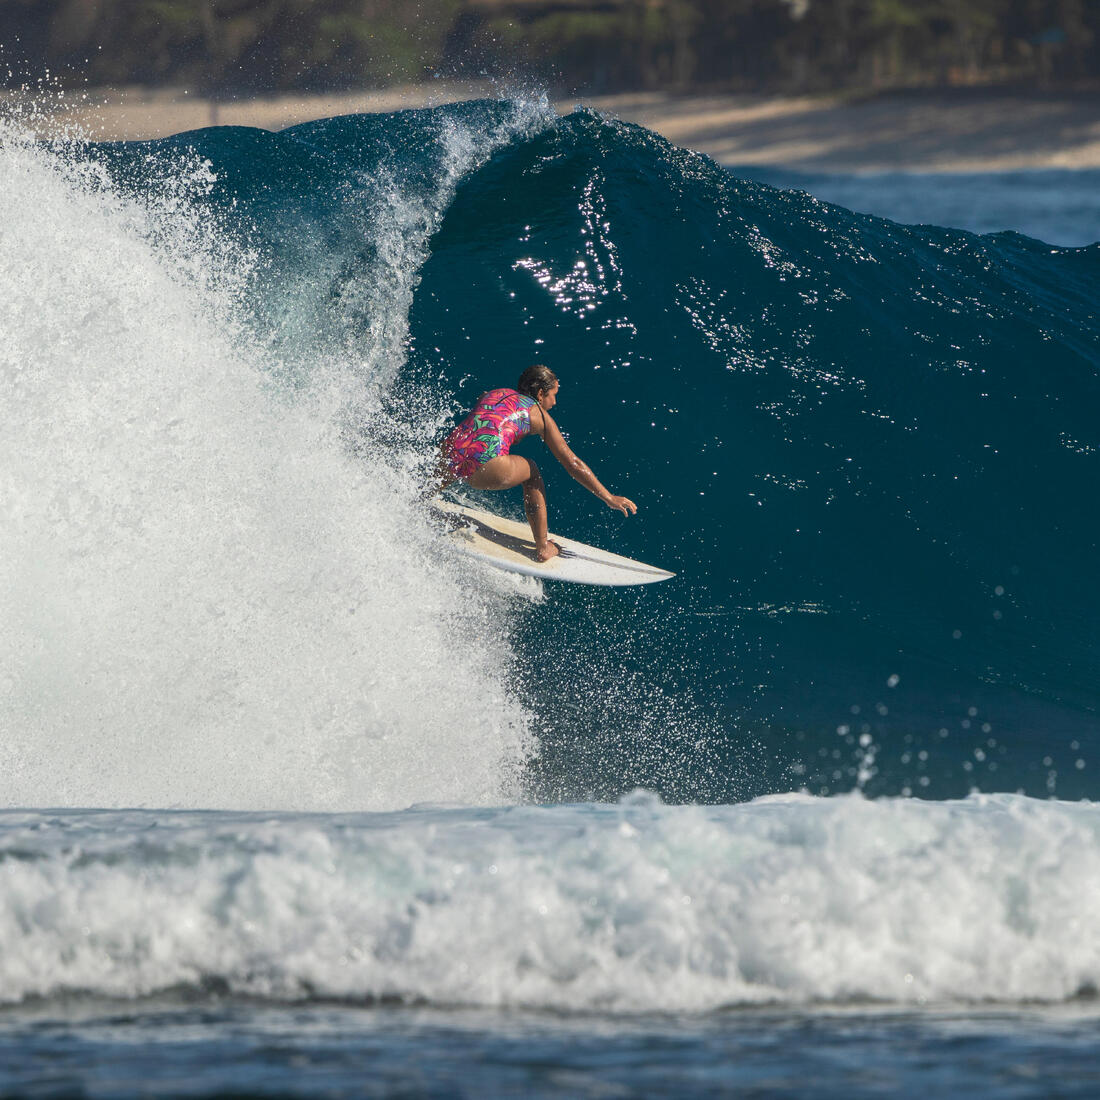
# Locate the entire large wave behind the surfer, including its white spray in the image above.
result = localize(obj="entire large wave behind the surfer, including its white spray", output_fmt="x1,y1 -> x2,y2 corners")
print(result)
0,102 -> 1100,809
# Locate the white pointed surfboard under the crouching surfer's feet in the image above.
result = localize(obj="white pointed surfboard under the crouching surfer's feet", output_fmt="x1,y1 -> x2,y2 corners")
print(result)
431,497 -> 677,586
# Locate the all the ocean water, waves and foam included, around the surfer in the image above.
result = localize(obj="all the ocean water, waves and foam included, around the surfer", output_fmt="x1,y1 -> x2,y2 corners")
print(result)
0,102 -> 1100,1097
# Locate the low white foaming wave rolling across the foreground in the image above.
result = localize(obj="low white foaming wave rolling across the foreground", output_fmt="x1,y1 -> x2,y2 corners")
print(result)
0,794 -> 1100,1012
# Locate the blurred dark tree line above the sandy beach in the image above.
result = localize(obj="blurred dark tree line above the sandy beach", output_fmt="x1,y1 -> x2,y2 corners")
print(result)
0,0 -> 1100,96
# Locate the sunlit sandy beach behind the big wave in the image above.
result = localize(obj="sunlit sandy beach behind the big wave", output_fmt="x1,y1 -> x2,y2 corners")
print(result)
12,84 -> 1100,174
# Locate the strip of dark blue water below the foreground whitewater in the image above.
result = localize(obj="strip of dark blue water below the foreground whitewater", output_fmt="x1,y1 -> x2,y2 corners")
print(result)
0,1001 -> 1100,1098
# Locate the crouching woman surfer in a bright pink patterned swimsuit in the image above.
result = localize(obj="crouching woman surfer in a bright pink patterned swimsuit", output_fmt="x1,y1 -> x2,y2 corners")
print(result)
439,365 -> 638,561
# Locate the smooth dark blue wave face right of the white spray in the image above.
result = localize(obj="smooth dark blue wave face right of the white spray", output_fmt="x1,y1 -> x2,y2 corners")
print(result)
411,111 -> 1100,800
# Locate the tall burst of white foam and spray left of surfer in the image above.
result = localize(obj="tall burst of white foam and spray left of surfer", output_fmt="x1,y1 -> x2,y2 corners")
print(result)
0,107 -> 547,809
